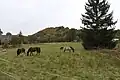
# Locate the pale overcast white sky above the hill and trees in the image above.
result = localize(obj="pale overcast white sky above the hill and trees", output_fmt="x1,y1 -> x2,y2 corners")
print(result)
0,0 -> 120,35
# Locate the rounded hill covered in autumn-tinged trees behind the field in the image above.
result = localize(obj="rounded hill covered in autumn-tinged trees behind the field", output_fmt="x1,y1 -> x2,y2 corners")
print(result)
28,26 -> 80,43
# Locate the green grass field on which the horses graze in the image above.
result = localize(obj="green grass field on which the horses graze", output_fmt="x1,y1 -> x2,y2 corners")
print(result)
0,43 -> 120,80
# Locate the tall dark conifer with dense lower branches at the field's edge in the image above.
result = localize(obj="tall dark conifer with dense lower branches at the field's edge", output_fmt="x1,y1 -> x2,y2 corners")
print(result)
81,0 -> 117,49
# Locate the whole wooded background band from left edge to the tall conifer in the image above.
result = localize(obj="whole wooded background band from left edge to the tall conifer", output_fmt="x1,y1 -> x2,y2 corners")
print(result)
0,26 -> 81,47
